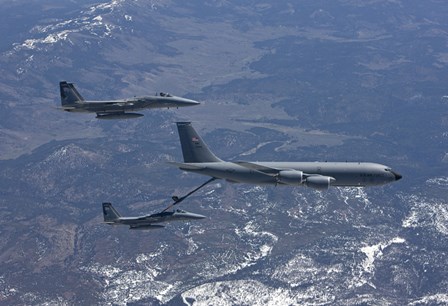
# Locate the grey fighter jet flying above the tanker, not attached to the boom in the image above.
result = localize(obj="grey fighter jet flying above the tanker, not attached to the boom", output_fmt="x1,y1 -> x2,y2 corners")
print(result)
59,81 -> 200,119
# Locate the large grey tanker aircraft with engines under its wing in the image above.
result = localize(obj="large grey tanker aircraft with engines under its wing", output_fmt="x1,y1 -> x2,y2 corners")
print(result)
171,122 -> 402,190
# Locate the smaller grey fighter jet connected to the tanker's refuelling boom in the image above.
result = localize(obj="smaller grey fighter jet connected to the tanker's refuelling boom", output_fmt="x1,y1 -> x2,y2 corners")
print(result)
103,203 -> 205,230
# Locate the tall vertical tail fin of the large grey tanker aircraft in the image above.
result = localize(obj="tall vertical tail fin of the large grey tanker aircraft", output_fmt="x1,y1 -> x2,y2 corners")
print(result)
177,122 -> 222,163
